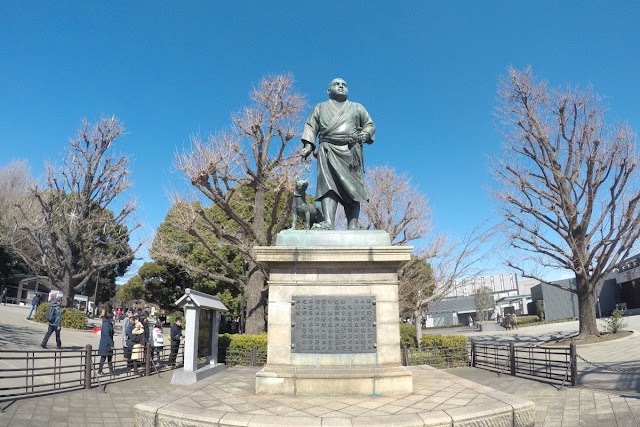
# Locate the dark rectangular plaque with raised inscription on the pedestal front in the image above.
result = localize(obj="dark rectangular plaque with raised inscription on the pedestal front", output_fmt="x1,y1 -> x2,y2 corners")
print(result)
291,295 -> 376,354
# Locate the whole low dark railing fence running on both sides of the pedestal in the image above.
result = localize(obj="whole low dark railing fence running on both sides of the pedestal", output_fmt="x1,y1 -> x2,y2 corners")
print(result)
0,343 -> 577,402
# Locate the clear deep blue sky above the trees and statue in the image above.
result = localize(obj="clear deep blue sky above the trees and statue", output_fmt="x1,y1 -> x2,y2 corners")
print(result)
0,0 -> 640,282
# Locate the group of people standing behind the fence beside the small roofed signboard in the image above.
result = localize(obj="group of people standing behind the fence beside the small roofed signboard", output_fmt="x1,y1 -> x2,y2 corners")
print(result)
98,310 -> 184,375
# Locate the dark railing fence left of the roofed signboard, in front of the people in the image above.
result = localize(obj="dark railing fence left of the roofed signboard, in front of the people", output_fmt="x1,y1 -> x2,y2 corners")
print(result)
0,345 -> 184,401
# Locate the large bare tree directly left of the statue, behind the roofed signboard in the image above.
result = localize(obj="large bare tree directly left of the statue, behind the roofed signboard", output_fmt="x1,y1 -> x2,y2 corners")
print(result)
154,75 -> 305,333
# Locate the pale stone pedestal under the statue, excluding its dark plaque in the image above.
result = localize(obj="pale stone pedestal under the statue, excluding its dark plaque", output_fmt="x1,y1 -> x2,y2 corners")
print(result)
255,230 -> 413,396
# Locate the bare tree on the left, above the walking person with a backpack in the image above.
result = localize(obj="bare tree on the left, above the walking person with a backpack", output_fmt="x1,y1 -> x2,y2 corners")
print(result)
5,117 -> 138,306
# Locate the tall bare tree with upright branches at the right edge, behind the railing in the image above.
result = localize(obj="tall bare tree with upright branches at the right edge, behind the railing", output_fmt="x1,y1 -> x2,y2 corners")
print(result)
494,68 -> 640,337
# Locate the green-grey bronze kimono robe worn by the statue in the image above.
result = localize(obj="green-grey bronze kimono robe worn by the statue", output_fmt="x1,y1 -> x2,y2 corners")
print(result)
302,99 -> 376,205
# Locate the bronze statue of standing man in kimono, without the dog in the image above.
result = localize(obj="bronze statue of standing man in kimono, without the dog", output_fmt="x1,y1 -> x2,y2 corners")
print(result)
300,79 -> 376,230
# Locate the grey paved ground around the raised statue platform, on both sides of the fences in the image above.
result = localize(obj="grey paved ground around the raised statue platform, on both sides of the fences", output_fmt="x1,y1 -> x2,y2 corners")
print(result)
0,306 -> 640,427
